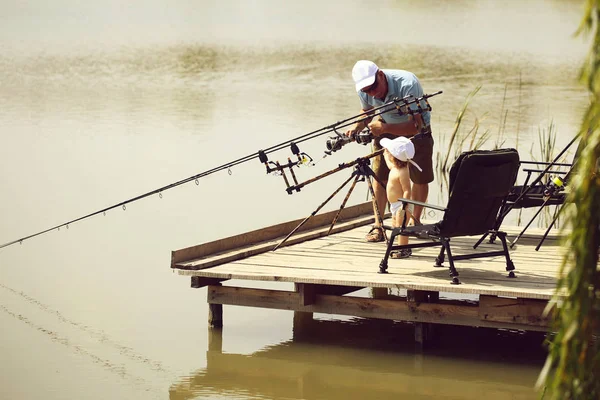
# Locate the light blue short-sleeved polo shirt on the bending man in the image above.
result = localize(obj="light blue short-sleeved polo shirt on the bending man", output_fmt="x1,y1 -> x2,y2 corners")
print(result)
358,69 -> 431,125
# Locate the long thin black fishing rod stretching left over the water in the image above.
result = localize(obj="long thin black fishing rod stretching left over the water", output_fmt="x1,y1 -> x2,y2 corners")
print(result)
0,91 -> 442,249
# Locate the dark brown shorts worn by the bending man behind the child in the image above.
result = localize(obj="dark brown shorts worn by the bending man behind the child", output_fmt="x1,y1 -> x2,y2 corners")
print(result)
372,134 -> 433,184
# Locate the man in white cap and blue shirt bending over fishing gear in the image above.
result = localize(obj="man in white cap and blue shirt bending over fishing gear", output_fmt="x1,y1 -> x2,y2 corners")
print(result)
346,60 -> 433,242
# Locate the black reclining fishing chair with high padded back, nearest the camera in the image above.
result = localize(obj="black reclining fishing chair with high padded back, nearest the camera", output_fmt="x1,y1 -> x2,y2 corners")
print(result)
379,149 -> 519,284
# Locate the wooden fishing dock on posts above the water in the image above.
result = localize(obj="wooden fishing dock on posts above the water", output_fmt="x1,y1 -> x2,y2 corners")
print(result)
171,202 -> 562,341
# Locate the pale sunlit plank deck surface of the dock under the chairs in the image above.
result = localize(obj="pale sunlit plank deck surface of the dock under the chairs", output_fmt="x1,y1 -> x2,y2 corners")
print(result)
173,217 -> 576,300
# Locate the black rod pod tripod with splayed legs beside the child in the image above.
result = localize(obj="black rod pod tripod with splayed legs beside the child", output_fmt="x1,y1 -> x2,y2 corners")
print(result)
272,149 -> 387,251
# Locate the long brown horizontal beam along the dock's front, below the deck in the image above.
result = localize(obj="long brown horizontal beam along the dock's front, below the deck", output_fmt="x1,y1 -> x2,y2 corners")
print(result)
208,286 -> 546,331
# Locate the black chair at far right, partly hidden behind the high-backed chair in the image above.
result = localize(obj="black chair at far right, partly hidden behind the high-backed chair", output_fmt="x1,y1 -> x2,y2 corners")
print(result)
475,136 -> 584,251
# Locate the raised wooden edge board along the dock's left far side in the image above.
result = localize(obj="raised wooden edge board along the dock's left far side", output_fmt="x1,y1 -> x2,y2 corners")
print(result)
171,202 -> 373,268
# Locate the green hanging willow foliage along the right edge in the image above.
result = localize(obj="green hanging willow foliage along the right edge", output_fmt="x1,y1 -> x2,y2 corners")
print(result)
539,0 -> 600,399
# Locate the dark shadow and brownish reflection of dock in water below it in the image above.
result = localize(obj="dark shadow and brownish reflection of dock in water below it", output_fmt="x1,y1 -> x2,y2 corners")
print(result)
169,316 -> 544,400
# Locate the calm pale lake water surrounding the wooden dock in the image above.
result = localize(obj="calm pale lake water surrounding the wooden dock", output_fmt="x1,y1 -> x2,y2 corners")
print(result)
0,0 -> 587,399
